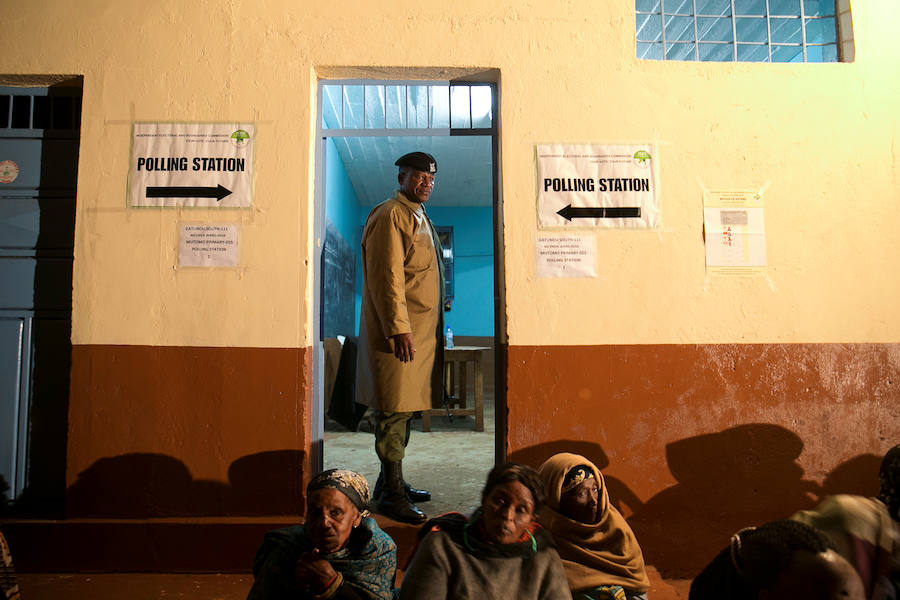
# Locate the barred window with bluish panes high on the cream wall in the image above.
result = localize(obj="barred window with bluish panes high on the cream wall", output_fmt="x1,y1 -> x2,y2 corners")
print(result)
634,0 -> 841,62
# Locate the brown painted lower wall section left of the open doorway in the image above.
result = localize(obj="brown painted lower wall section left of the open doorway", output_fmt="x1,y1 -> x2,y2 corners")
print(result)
66,346 -> 311,518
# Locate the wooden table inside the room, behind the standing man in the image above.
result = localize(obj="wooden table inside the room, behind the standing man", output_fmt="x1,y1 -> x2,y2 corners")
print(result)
422,346 -> 490,431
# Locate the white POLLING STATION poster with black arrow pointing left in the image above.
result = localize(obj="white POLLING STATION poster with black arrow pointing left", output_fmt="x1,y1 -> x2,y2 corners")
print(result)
537,144 -> 659,229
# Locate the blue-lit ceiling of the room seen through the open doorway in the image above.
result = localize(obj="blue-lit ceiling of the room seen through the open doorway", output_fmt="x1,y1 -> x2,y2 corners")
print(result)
322,81 -> 493,206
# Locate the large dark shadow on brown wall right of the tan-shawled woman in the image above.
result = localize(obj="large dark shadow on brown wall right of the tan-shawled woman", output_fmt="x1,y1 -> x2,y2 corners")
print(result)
629,424 -> 820,578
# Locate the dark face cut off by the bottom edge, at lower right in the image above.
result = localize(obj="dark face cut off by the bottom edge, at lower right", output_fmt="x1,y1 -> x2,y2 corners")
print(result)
759,550 -> 866,600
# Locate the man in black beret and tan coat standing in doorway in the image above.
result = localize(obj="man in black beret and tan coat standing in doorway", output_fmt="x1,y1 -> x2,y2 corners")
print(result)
356,152 -> 444,523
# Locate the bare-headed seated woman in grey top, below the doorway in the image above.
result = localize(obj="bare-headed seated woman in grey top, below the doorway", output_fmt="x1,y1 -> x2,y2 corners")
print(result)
400,463 -> 571,600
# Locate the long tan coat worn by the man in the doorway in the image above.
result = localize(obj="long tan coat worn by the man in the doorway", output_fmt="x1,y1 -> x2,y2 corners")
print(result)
356,191 -> 444,412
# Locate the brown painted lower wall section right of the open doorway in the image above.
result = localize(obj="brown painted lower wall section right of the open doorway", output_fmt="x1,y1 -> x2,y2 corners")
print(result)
507,344 -> 900,576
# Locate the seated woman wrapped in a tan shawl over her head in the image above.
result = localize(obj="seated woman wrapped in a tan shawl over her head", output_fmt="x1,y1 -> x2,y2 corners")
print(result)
538,453 -> 650,600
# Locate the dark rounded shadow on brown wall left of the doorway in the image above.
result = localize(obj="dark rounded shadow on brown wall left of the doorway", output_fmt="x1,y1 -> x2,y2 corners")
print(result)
66,450 -> 305,518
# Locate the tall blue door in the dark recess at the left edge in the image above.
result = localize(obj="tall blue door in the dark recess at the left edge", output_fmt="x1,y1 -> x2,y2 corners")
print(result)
0,85 -> 81,506
